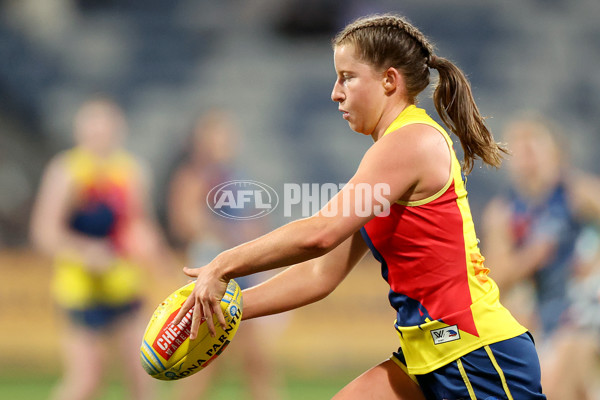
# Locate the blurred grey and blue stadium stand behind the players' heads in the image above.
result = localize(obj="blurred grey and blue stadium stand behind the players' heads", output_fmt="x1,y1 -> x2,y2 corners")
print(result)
0,0 -> 600,244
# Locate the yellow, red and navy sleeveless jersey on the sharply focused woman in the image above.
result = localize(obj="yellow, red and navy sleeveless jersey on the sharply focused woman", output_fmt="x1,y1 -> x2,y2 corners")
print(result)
361,105 -> 526,374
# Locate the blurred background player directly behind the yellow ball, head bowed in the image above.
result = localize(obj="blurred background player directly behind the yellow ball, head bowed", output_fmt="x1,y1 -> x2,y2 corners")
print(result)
168,108 -> 282,400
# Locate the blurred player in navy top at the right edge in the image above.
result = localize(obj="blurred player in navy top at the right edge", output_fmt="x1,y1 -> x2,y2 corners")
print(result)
484,117 -> 600,400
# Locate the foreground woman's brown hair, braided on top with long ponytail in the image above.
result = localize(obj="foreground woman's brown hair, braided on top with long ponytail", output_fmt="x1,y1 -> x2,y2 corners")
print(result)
333,14 -> 508,174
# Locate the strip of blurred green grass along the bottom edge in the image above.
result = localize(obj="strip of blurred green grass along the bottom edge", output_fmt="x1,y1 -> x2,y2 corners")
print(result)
0,376 -> 351,400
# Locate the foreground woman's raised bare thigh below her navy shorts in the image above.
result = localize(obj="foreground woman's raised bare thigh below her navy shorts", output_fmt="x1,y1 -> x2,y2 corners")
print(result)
333,360 -> 425,400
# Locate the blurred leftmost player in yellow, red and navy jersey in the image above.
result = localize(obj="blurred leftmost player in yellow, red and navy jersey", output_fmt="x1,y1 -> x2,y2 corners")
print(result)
31,97 -> 174,400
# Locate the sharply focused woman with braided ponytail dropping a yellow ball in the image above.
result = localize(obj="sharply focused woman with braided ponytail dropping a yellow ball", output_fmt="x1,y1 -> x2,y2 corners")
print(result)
176,15 -> 545,400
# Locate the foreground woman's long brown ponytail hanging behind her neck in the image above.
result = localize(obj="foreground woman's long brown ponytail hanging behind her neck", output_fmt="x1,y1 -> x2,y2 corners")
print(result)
428,56 -> 508,174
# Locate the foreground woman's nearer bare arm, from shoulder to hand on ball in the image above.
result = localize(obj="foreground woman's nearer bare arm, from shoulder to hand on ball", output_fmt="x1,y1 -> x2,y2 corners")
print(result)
174,125 -> 449,337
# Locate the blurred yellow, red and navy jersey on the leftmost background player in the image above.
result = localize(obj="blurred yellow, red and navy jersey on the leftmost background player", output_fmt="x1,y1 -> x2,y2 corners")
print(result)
52,147 -> 142,309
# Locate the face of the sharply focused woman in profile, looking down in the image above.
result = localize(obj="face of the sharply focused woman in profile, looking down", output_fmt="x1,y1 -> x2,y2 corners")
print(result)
331,45 -> 385,135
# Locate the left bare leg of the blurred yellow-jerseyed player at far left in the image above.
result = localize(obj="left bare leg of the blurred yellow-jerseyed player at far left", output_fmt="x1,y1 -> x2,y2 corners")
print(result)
51,324 -> 105,400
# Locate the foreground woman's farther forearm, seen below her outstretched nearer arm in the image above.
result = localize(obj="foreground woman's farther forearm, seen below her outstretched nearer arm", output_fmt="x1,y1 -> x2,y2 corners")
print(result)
242,232 -> 368,319
